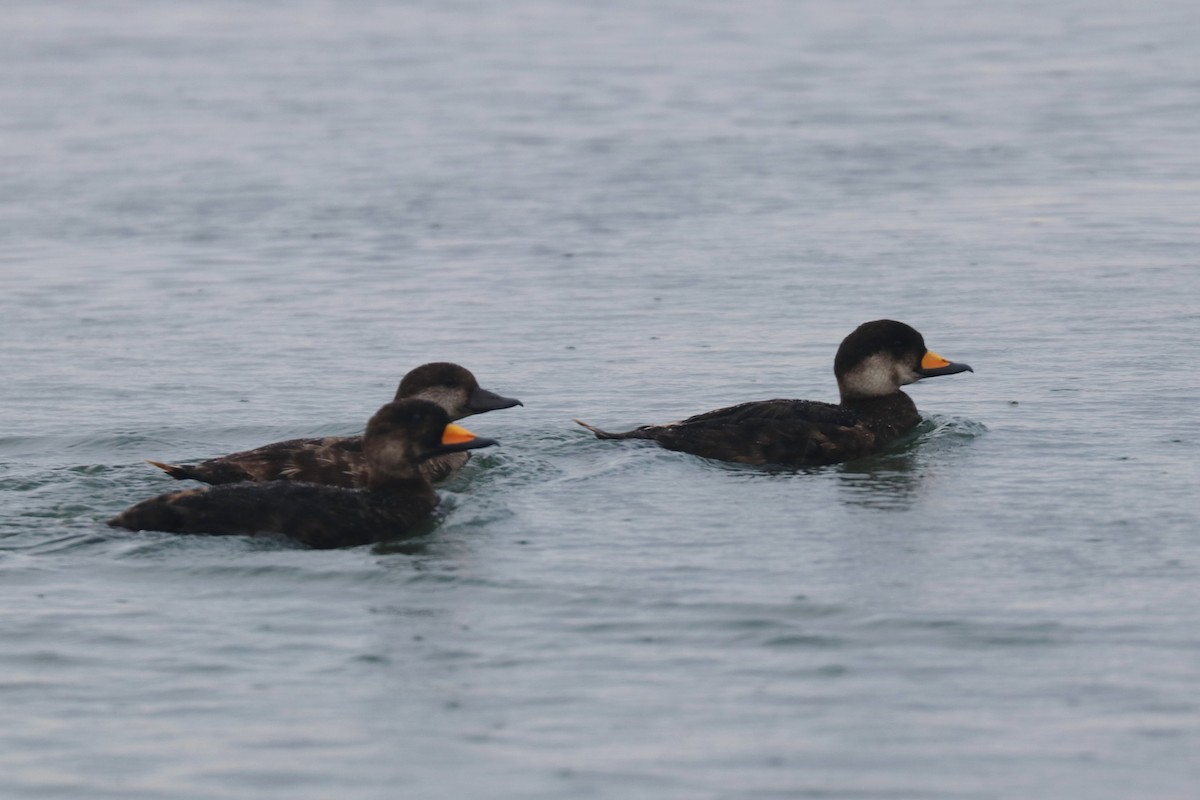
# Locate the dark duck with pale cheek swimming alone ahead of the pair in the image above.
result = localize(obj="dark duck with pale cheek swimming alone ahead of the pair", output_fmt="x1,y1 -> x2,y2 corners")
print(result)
576,319 -> 974,467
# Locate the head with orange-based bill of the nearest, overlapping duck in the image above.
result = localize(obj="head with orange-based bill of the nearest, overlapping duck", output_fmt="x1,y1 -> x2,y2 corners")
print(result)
362,399 -> 498,486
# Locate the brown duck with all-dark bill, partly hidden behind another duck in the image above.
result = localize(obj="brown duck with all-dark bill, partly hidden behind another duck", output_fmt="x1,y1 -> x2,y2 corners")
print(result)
148,362 -> 522,488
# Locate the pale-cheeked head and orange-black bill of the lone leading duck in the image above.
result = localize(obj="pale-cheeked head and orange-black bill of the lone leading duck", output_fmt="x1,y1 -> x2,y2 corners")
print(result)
833,319 -> 974,402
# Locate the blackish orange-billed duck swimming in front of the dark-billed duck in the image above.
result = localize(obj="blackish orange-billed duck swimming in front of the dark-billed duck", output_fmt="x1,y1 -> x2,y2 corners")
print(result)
108,399 -> 497,549
